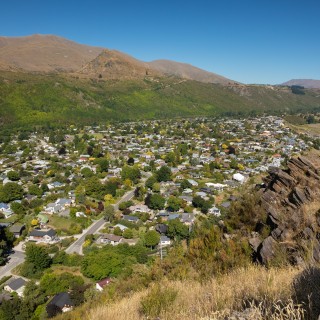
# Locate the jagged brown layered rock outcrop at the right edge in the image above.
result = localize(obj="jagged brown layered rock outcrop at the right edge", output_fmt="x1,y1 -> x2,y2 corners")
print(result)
250,154 -> 320,265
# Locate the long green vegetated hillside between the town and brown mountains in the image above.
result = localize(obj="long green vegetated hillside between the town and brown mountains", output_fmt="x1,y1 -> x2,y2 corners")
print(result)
0,71 -> 320,127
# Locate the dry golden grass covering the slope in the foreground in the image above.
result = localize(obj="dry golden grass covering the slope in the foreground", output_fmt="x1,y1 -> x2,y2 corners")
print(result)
74,266 -> 303,320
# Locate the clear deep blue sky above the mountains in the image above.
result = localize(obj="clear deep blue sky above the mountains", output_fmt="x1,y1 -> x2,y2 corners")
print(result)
0,0 -> 320,84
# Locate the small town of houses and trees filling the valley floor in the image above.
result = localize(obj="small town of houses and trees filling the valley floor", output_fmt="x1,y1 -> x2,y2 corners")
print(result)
0,116 -> 313,316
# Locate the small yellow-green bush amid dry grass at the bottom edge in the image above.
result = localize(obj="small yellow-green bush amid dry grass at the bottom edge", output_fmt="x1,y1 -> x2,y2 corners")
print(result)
141,284 -> 177,319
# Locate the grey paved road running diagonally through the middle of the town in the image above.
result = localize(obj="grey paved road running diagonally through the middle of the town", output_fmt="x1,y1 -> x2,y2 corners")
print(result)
66,190 -> 134,254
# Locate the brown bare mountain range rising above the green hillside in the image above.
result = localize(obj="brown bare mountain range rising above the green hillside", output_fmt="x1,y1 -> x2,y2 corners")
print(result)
0,35 -> 234,84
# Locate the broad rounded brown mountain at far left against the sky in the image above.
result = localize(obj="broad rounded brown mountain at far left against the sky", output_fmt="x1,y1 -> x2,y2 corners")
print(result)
0,35 -> 103,72
